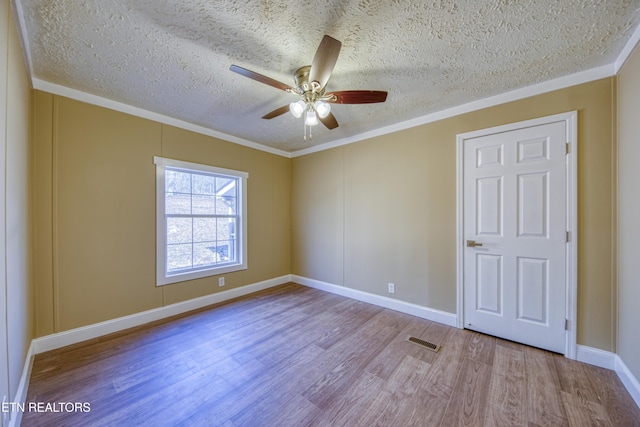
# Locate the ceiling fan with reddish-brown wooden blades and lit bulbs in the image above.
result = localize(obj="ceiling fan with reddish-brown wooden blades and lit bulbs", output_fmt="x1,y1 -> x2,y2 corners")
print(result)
229,35 -> 387,131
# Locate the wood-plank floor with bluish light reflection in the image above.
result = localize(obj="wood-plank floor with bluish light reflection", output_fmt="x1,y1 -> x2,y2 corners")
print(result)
22,284 -> 640,427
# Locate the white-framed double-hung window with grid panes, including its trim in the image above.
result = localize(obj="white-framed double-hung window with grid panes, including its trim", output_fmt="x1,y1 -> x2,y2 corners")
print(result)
154,157 -> 249,286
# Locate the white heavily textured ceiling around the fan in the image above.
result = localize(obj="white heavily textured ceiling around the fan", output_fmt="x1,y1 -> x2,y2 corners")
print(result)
15,0 -> 640,151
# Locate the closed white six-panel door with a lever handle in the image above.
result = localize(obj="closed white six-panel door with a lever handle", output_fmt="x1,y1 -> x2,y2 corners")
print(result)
462,121 -> 567,353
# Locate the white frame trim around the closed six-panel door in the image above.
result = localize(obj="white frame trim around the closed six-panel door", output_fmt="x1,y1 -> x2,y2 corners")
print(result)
456,111 -> 578,359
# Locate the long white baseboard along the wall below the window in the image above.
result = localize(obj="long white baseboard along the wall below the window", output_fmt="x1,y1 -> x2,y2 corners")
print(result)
32,275 -> 291,354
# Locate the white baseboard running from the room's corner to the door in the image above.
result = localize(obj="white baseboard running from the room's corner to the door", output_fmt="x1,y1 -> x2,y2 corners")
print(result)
291,275 -> 457,327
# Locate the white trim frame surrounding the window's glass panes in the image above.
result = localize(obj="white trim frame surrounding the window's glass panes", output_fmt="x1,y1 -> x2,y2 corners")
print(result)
153,156 -> 249,286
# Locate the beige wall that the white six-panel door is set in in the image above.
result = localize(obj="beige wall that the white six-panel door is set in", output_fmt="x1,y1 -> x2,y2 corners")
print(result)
292,78 -> 616,351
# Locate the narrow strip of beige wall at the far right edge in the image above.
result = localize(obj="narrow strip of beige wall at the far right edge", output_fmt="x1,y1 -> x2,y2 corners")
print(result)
618,46 -> 640,379
